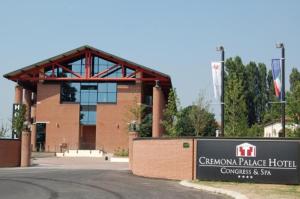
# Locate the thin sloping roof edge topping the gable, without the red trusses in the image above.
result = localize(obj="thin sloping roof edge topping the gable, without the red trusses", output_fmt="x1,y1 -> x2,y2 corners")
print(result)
3,45 -> 171,84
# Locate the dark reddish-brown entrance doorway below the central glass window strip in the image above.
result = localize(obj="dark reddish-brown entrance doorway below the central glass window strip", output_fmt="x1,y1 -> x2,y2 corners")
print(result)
80,125 -> 96,150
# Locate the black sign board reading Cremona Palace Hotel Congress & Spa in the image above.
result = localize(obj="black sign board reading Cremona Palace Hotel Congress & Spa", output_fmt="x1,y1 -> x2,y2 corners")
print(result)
196,139 -> 300,184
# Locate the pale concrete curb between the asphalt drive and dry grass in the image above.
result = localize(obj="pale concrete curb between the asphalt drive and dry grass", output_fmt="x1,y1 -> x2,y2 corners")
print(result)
179,180 -> 248,199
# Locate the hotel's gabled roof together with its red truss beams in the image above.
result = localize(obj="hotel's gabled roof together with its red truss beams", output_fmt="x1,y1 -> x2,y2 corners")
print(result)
4,45 -> 172,91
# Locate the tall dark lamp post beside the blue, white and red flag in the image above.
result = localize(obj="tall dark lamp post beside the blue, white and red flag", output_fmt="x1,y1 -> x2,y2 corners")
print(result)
276,43 -> 285,137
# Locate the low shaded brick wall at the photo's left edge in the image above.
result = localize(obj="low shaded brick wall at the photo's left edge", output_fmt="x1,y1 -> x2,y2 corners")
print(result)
0,139 -> 21,167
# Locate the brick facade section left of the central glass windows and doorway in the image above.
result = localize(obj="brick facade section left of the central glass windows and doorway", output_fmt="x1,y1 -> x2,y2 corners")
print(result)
36,83 -> 80,151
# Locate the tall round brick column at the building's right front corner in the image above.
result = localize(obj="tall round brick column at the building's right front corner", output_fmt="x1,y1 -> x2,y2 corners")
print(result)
152,82 -> 164,137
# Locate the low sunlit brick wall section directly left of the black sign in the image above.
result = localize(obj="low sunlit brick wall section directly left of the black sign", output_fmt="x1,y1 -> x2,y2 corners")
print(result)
132,139 -> 194,180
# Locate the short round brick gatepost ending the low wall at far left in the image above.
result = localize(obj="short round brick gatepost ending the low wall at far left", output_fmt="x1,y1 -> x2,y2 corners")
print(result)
21,131 -> 31,167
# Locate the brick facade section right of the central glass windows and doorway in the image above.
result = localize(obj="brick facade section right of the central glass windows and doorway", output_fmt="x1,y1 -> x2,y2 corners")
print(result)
96,84 -> 141,153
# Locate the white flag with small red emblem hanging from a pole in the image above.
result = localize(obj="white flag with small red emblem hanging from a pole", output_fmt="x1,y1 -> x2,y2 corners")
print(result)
211,62 -> 222,99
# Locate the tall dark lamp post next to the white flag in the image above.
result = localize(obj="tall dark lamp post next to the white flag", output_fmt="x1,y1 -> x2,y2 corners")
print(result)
216,46 -> 225,137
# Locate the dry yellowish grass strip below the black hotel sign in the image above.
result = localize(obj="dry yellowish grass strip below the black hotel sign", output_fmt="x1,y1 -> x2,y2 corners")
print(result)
194,180 -> 300,199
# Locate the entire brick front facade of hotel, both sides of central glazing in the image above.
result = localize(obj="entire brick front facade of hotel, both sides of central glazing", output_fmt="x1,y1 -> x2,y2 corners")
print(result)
36,83 -> 142,152
